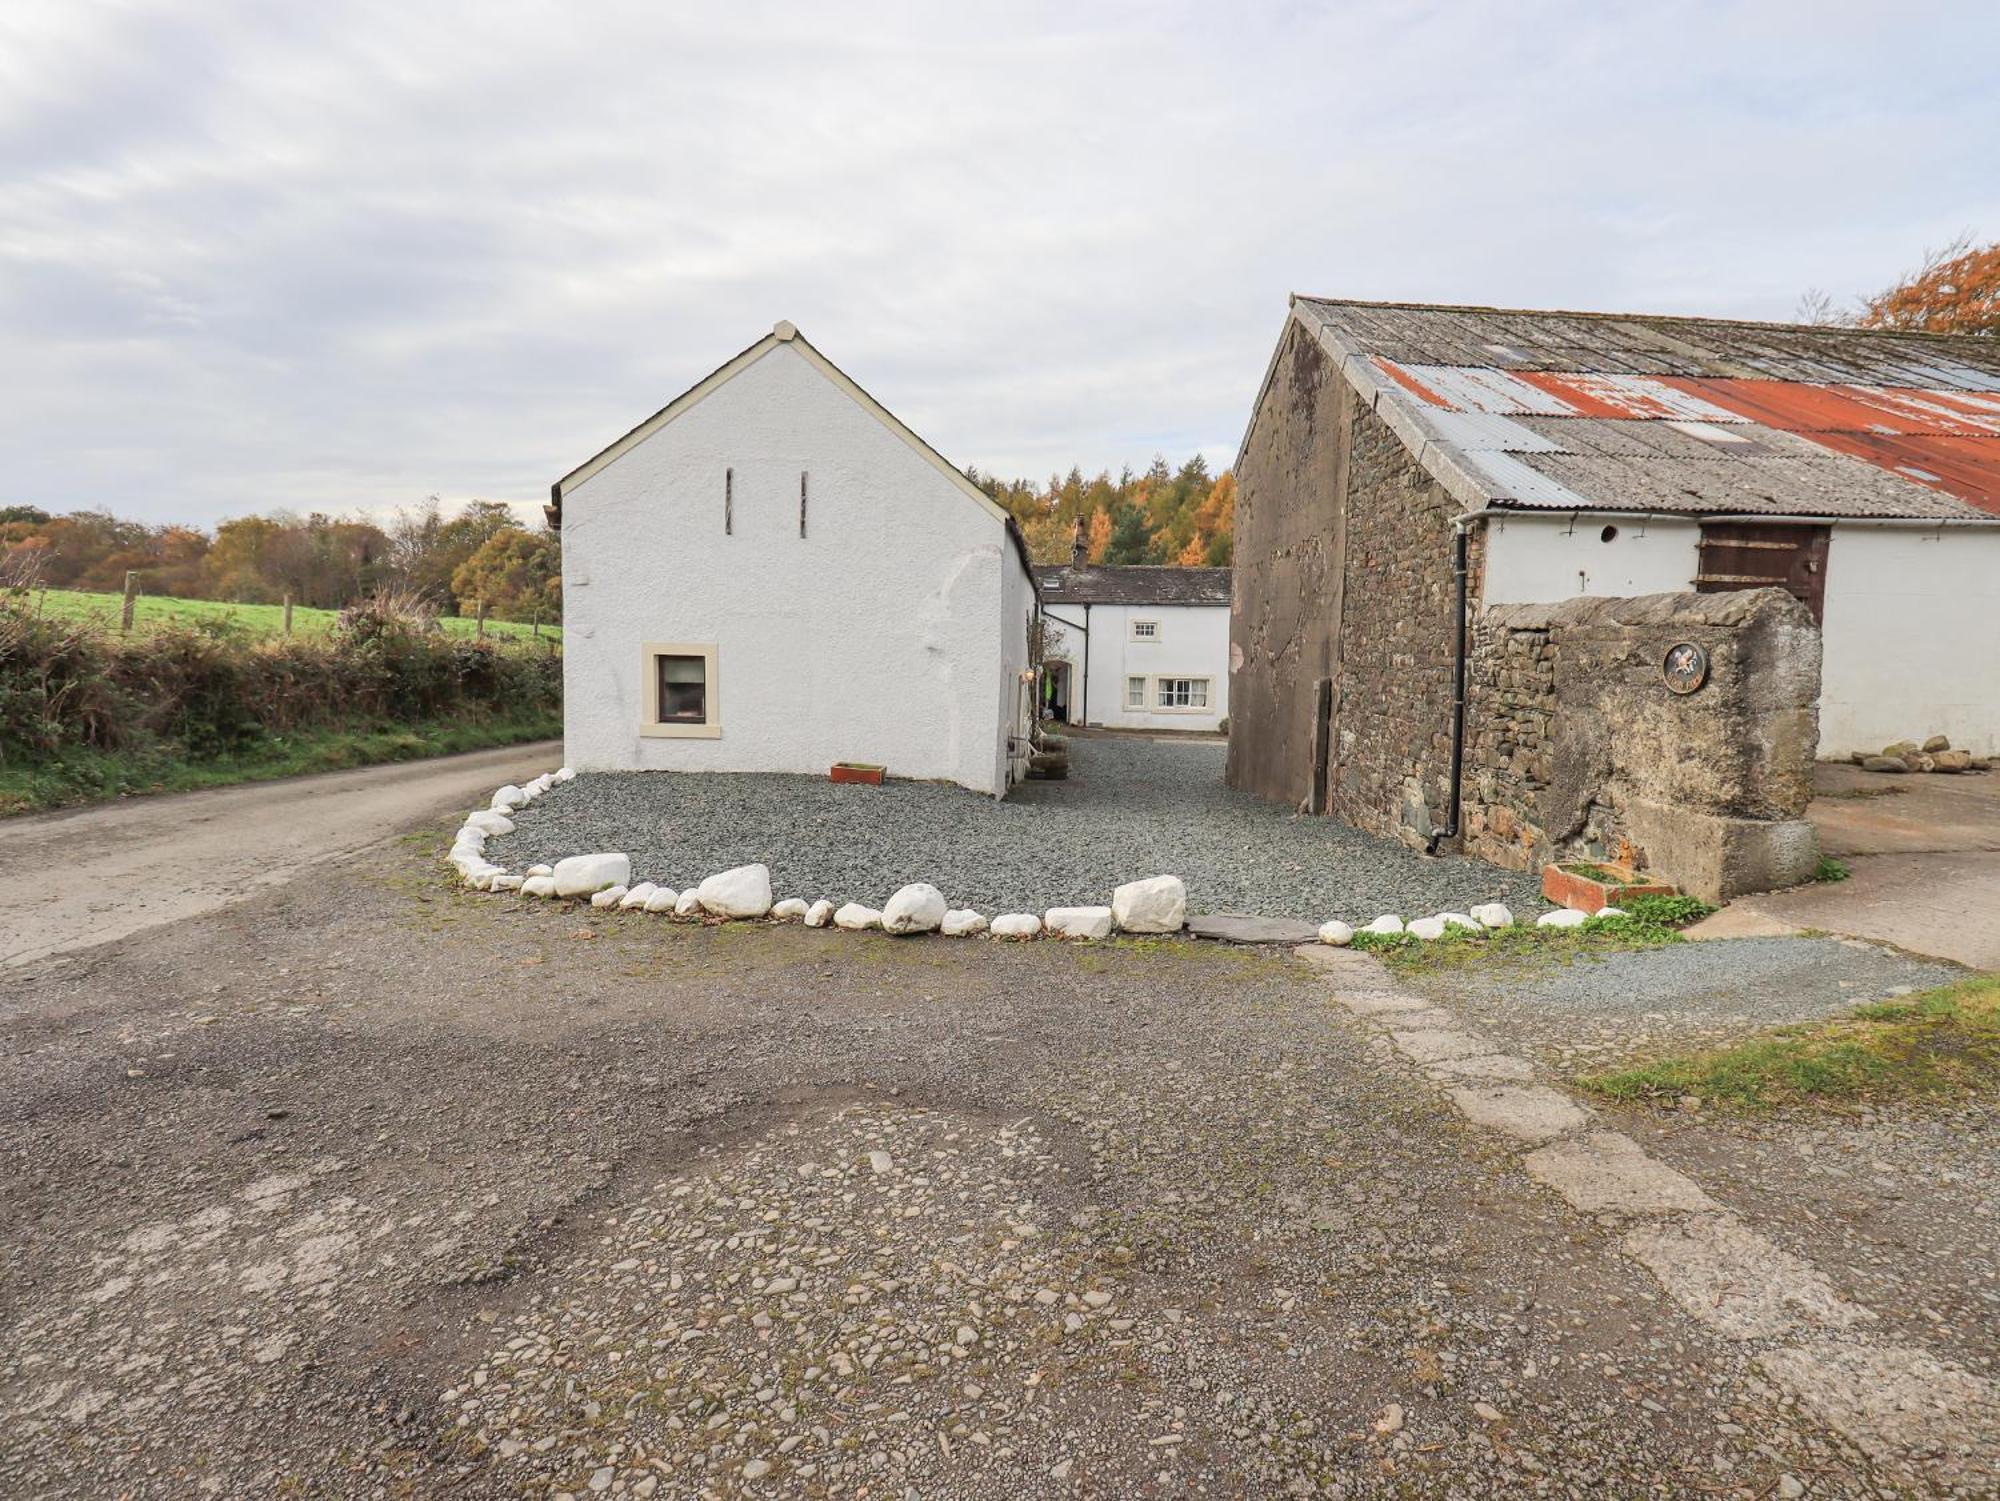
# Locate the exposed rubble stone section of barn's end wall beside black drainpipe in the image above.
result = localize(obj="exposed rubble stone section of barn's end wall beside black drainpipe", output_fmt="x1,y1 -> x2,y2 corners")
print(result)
1326,404 -> 1464,847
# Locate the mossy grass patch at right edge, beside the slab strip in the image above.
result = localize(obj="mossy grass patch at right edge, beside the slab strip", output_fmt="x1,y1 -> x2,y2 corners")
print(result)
1578,975 -> 2000,1111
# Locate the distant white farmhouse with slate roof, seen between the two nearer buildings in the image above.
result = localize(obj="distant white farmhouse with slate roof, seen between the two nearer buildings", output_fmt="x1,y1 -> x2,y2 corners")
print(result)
1034,562 -> 1230,730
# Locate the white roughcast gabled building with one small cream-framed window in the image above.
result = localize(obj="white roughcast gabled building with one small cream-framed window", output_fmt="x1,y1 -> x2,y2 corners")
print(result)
550,322 -> 1036,795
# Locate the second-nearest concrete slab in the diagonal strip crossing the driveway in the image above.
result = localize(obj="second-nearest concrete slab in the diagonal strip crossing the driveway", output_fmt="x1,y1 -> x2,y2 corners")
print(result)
1624,1215 -> 1874,1339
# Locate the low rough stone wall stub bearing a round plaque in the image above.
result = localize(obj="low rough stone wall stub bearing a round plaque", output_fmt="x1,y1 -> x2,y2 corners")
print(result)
1462,588 -> 1820,901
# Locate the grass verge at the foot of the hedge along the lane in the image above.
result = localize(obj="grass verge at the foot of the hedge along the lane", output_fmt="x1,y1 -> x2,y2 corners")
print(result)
0,714 -> 562,817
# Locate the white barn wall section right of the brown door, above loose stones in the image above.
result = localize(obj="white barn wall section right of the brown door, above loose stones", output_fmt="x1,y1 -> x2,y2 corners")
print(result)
1820,522 -> 2000,757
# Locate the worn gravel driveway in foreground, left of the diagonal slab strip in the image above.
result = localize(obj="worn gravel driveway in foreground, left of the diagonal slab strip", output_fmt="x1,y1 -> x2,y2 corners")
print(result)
0,841 -> 1886,1501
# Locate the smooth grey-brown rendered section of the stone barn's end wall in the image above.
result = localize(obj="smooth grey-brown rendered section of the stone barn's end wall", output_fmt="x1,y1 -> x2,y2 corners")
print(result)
1226,322 -> 1354,807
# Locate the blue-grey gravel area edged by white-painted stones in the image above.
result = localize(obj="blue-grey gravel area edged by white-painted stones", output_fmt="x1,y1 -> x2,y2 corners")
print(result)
488,736 -> 1544,923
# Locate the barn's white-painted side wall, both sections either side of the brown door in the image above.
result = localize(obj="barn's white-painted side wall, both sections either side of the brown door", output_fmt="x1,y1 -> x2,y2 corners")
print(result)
1484,514 -> 2000,759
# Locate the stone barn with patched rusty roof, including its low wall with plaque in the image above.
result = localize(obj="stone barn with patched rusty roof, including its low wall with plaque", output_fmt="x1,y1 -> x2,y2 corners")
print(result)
1228,298 -> 2000,897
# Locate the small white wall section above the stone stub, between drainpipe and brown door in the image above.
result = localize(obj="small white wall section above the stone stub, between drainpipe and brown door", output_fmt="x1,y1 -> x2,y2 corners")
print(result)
1480,512 -> 1702,604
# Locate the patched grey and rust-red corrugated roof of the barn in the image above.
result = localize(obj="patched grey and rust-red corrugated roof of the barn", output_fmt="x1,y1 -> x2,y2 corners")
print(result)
1294,298 -> 2000,520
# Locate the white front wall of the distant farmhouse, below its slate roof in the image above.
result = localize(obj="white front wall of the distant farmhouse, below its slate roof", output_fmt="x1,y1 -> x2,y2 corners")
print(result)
1048,604 -> 1230,730
